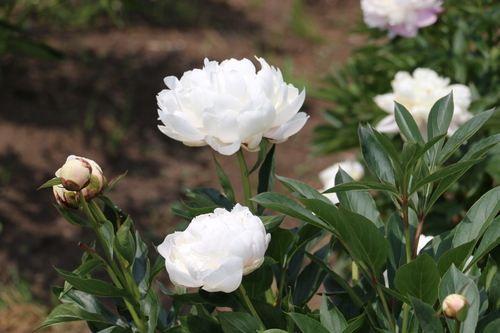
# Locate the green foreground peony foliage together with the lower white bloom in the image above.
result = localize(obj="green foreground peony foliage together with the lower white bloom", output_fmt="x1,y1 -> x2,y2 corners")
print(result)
39,56 -> 500,333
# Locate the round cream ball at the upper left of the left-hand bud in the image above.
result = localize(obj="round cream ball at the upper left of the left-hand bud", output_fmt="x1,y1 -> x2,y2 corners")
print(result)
56,158 -> 92,191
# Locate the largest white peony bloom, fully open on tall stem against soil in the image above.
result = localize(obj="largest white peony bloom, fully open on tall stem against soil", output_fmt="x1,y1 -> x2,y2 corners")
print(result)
157,58 -> 308,155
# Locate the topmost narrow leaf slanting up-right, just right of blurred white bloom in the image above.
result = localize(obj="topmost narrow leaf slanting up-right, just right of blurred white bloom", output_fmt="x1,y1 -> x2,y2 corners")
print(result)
438,109 -> 494,165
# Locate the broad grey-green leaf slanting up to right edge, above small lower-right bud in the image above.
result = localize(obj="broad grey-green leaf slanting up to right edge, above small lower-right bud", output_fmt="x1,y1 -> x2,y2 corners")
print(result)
453,187 -> 500,247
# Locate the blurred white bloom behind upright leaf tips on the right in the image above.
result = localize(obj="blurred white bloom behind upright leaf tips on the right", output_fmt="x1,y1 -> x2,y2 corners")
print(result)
374,68 -> 472,138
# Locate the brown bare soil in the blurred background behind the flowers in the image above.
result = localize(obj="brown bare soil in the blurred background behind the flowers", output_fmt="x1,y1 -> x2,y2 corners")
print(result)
0,0 -> 361,320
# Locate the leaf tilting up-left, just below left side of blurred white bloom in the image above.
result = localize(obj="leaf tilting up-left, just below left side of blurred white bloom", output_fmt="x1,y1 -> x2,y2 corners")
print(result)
358,125 -> 394,184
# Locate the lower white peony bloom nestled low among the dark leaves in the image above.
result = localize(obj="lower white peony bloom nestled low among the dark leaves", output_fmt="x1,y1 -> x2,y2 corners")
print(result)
158,204 -> 271,293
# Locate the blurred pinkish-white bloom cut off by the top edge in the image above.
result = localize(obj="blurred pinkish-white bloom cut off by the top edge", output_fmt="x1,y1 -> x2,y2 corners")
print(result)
361,0 -> 442,38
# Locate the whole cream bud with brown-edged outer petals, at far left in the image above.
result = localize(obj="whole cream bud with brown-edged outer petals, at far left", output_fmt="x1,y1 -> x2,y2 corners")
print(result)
53,155 -> 108,204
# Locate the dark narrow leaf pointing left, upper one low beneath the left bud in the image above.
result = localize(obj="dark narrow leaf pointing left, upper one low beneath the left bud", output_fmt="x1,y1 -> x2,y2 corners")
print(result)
56,268 -> 130,298
